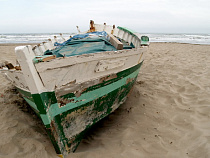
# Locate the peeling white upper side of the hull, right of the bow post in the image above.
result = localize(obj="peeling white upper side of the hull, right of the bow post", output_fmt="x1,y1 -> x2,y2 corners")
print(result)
35,49 -> 146,90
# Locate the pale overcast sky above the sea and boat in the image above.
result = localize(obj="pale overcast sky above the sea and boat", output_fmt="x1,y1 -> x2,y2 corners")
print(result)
0,0 -> 210,34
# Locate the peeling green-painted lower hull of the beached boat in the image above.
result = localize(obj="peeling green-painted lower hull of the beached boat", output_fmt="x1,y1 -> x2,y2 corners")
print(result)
18,63 -> 142,156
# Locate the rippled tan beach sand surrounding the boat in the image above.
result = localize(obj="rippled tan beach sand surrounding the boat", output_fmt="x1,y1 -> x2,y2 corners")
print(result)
0,43 -> 210,158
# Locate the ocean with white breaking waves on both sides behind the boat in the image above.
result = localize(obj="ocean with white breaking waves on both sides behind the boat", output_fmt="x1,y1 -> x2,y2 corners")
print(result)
0,33 -> 210,45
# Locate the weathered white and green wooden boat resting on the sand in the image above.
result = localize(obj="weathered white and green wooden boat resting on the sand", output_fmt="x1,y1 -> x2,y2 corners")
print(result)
1,21 -> 149,157
